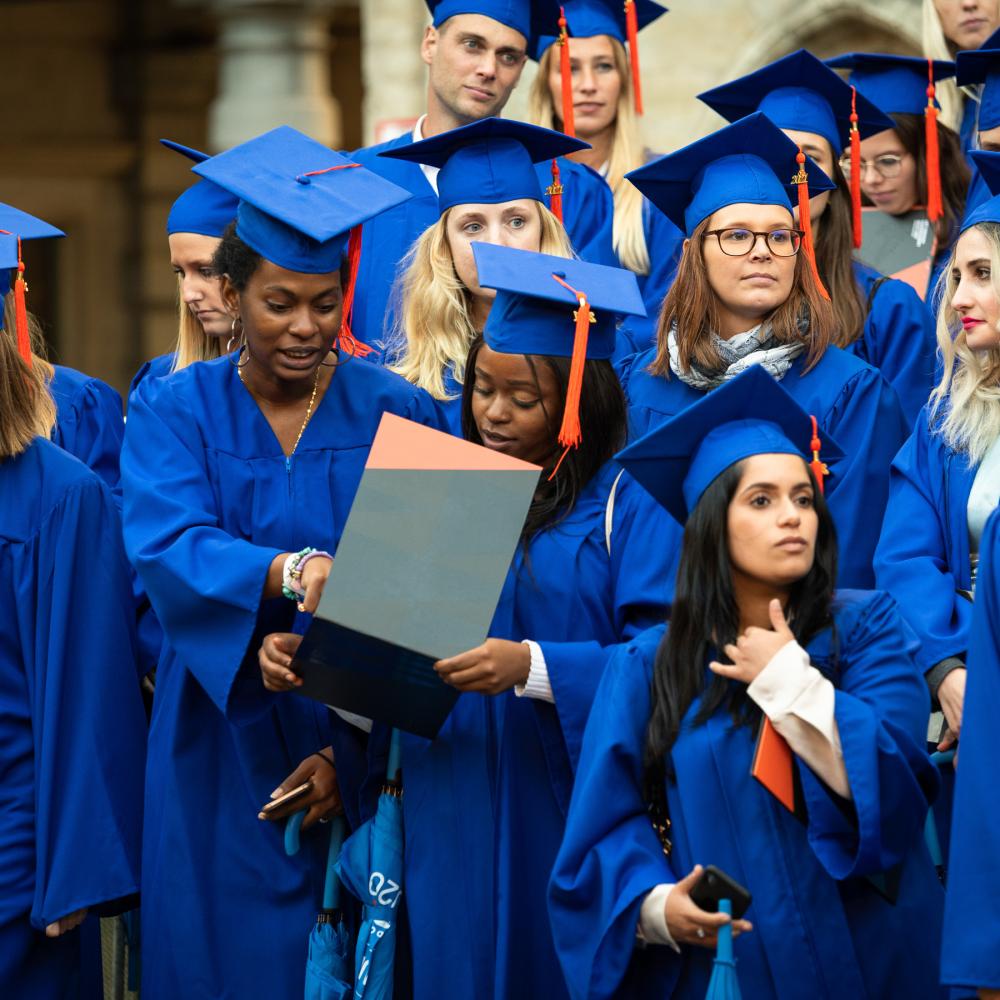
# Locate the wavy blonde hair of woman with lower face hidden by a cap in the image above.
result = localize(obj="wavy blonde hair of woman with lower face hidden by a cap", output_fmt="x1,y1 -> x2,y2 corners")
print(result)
387,201 -> 573,399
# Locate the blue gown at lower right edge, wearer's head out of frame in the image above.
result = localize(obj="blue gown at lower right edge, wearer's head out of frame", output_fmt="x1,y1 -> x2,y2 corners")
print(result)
941,511 -> 1000,988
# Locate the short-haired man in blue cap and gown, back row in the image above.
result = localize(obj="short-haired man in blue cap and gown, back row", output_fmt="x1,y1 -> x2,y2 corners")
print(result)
352,0 -> 615,356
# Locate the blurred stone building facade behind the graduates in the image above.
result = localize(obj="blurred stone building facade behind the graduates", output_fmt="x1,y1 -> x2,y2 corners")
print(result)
0,0 -> 920,390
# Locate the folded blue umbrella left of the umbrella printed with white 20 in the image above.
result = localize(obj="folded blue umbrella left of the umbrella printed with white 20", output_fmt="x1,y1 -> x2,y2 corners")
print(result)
285,809 -> 353,1000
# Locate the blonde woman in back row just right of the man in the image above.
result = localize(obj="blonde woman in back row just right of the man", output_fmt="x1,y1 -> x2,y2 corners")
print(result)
528,0 -> 683,346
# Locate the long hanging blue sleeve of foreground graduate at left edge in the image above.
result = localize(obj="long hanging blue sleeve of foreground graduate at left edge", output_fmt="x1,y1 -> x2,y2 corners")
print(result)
14,477 -> 146,930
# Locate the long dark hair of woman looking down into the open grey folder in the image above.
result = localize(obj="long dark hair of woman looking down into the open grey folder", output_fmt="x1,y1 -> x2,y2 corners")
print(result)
462,334 -> 628,548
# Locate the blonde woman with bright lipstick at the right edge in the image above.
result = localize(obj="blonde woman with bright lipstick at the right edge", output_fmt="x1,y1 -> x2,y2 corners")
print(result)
875,158 -> 1000,752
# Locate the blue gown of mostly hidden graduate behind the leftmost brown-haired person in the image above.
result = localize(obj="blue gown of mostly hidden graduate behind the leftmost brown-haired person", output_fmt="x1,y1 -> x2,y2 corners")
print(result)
49,365 -> 125,490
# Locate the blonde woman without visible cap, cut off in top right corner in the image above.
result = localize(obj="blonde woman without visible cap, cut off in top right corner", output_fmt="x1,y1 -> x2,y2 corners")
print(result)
921,0 -> 1000,153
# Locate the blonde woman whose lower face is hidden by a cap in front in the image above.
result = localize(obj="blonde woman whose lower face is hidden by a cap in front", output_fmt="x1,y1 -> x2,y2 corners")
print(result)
381,118 -> 584,435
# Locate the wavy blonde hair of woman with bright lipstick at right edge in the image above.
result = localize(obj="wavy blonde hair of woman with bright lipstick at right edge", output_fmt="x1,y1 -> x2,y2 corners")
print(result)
930,222 -> 1000,463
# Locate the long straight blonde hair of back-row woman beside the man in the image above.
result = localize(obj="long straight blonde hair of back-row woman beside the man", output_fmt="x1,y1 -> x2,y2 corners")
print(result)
528,36 -> 650,274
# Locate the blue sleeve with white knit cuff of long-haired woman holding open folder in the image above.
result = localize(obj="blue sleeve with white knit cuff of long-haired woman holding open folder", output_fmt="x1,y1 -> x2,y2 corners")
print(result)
529,473 -> 681,767
